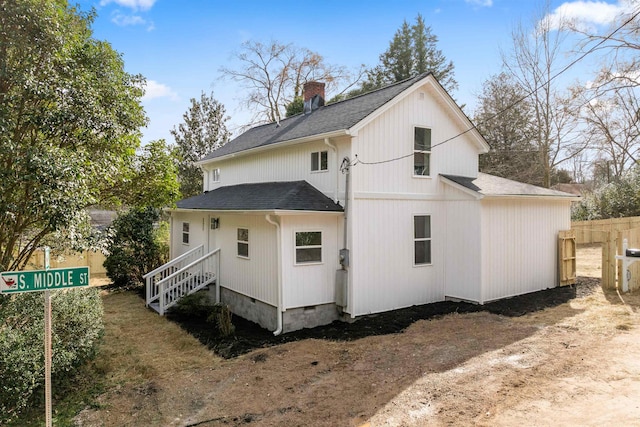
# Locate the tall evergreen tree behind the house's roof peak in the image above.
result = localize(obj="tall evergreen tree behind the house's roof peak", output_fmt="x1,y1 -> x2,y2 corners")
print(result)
347,14 -> 458,97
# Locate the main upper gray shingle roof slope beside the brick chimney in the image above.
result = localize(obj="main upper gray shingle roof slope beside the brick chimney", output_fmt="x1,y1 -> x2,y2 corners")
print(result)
200,73 -> 430,161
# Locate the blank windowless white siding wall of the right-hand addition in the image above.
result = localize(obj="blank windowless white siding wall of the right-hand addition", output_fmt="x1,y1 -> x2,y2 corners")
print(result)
480,199 -> 571,303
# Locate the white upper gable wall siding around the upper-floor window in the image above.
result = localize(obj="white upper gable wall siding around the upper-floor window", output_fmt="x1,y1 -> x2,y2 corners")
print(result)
352,85 -> 478,195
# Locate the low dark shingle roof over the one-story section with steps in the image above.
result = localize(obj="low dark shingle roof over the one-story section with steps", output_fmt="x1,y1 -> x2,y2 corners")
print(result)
176,181 -> 343,212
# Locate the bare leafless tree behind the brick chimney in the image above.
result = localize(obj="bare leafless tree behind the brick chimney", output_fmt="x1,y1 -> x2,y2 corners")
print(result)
220,41 -> 350,123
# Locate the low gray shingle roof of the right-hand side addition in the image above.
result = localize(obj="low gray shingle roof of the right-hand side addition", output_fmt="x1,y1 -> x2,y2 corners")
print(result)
441,172 -> 576,198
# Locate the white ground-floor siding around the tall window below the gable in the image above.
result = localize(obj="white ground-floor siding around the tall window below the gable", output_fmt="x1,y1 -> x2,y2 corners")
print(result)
347,199 -> 445,316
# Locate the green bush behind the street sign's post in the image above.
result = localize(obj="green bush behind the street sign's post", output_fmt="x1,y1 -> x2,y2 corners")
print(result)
0,288 -> 104,425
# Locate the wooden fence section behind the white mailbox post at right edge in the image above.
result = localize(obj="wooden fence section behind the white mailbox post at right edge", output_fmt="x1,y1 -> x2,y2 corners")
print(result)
602,228 -> 640,292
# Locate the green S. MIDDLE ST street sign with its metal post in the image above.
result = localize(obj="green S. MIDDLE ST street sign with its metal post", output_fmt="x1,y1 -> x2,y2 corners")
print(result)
0,247 -> 89,427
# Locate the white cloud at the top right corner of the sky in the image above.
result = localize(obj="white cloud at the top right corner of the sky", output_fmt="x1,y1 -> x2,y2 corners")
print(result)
544,0 -> 632,30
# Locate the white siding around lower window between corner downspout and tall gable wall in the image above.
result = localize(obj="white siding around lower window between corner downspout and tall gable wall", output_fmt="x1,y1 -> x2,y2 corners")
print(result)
281,215 -> 342,309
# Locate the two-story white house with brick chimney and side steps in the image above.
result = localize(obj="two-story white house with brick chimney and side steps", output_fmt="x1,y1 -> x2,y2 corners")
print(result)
147,74 -> 575,334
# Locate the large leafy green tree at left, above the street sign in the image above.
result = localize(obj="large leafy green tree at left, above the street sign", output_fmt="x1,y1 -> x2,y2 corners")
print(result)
0,0 -> 155,270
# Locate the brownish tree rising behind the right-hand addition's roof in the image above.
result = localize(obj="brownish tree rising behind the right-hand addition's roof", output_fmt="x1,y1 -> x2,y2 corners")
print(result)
474,73 -> 541,185
